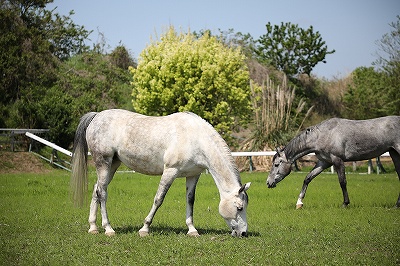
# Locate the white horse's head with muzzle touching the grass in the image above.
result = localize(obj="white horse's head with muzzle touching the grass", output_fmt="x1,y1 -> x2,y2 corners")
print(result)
219,182 -> 251,237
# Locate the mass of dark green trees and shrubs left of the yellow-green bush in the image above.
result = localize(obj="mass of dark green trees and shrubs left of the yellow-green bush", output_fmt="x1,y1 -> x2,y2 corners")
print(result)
0,0 -> 135,148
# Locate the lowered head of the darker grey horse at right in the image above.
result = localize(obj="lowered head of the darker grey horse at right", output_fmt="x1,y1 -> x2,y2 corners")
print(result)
267,148 -> 292,188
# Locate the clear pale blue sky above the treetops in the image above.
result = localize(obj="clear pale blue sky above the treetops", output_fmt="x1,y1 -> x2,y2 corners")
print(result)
48,0 -> 400,79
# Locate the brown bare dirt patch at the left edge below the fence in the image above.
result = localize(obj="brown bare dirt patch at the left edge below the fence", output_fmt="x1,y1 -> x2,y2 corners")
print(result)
0,151 -> 51,174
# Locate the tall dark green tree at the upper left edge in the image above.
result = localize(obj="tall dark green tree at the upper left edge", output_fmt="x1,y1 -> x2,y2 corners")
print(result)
0,0 -> 89,128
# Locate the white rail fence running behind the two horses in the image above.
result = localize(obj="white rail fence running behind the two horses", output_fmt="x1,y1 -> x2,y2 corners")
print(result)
25,132 -> 390,174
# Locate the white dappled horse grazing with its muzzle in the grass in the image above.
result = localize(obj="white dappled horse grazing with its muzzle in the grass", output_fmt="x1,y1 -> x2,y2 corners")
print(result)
71,109 -> 250,236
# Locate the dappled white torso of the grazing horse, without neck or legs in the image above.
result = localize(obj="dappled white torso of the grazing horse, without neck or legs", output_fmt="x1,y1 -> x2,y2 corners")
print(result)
86,109 -> 217,175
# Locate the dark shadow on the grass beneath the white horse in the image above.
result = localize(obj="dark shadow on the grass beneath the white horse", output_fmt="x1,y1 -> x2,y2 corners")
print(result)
114,225 -> 261,237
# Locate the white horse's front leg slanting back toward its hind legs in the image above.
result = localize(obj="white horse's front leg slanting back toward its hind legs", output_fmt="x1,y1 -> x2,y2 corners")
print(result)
139,168 -> 178,236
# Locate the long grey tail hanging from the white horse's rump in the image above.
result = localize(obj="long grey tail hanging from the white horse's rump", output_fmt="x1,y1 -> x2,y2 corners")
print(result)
70,112 -> 97,207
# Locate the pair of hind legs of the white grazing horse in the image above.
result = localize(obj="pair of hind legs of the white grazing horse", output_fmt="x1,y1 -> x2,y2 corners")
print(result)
89,156 -> 121,236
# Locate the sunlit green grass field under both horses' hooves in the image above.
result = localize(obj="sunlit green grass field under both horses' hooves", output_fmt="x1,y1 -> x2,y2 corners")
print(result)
0,170 -> 400,265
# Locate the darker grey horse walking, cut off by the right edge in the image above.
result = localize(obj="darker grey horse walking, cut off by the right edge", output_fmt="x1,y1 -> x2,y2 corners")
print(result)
267,116 -> 400,208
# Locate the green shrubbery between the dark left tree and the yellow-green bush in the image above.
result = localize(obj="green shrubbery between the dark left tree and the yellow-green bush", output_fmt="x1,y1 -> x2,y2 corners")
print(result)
44,51 -> 132,147
